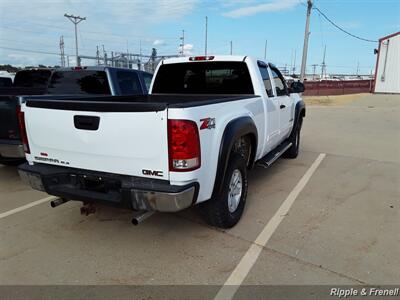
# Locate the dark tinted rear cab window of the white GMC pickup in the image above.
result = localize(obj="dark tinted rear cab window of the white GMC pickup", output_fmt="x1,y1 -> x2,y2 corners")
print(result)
152,62 -> 254,94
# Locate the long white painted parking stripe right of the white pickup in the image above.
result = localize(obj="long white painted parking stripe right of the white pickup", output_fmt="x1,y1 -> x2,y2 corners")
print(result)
214,153 -> 326,300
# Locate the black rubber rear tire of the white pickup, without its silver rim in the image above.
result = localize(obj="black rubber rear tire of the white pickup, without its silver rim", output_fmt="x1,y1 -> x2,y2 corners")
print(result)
200,153 -> 248,228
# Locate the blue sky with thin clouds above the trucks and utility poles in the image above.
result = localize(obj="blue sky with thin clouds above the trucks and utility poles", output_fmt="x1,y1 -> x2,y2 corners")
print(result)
0,0 -> 400,74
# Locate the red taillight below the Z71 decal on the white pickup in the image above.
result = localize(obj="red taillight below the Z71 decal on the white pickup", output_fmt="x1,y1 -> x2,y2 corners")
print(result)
168,120 -> 201,172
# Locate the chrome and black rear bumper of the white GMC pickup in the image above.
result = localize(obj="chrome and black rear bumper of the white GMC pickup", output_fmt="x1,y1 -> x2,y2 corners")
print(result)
18,163 -> 199,212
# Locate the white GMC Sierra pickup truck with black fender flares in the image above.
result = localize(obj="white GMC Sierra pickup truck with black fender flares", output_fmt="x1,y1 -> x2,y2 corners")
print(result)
19,56 -> 305,228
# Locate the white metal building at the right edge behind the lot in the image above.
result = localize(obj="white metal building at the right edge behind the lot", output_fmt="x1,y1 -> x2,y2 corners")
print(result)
375,31 -> 400,93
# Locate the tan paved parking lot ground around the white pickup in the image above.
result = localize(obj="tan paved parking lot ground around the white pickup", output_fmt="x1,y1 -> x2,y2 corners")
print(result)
0,95 -> 400,293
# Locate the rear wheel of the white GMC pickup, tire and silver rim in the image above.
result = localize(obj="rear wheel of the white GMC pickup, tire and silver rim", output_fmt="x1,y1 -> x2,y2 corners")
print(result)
201,153 -> 248,228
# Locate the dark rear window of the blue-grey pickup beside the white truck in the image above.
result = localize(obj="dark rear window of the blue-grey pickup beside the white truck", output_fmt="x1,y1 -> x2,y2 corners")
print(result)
48,70 -> 110,95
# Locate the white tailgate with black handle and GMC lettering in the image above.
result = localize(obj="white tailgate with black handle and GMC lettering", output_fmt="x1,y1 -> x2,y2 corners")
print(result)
23,100 -> 169,179
